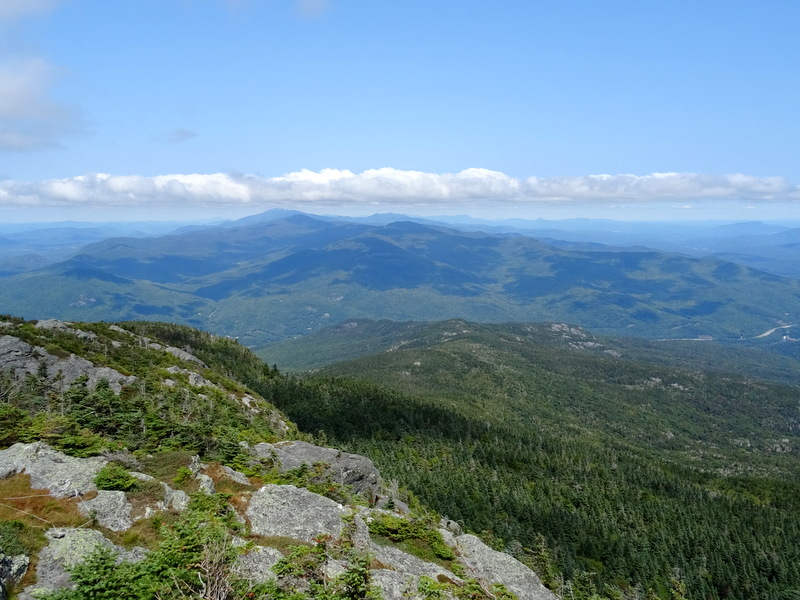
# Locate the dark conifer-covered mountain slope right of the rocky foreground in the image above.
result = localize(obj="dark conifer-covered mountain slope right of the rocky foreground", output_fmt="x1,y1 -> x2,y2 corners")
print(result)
260,321 -> 800,600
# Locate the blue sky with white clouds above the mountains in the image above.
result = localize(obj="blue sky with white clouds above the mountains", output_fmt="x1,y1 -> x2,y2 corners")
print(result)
0,0 -> 800,221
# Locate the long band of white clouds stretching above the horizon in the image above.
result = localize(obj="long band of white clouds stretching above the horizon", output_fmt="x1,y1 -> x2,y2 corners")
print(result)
0,168 -> 800,210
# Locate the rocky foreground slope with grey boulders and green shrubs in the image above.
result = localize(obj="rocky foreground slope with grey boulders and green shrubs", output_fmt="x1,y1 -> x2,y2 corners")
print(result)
0,316 -> 555,600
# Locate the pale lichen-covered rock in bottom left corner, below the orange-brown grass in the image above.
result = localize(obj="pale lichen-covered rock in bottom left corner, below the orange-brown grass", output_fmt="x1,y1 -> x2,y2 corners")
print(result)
19,528 -> 146,600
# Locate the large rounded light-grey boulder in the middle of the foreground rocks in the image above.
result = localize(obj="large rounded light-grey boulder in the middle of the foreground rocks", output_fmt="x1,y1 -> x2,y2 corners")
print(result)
246,484 -> 348,542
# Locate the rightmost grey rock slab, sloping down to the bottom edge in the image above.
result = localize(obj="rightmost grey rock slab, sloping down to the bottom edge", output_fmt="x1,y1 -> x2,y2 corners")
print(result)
456,534 -> 556,600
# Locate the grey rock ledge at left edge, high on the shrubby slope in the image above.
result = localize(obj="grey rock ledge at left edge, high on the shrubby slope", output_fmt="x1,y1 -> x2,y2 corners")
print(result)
0,335 -> 136,393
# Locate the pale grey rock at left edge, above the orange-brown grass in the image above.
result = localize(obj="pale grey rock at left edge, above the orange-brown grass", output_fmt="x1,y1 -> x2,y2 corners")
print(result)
0,442 -> 108,498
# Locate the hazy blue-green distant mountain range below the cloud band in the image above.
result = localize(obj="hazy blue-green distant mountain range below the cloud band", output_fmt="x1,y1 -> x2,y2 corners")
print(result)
0,211 -> 800,347
